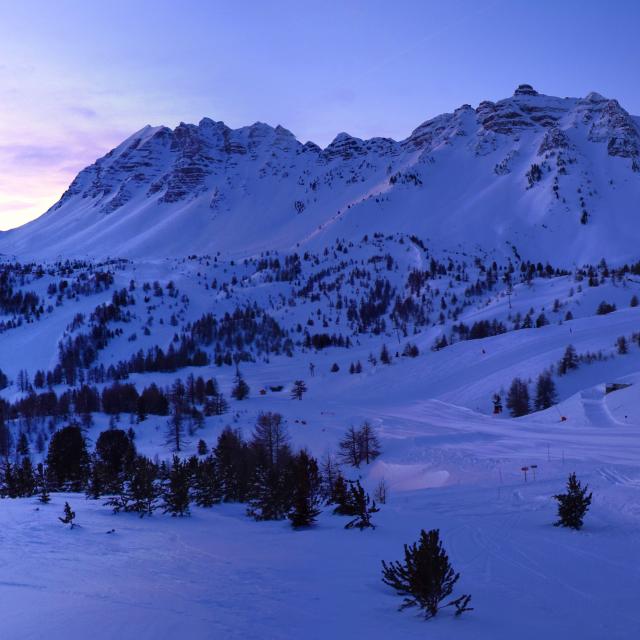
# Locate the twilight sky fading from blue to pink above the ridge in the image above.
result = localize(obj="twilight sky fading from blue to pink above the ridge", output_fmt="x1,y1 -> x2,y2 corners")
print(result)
0,0 -> 640,229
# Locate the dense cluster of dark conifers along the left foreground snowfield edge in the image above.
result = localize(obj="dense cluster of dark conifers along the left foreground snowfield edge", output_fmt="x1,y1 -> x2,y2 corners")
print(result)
0,413 -> 378,529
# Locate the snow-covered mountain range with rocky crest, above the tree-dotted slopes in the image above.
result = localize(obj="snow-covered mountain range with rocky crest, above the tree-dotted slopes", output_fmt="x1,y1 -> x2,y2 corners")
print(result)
0,85 -> 640,266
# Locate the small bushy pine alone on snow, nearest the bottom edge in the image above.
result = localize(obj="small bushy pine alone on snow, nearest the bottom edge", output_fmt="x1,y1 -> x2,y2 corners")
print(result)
382,529 -> 473,620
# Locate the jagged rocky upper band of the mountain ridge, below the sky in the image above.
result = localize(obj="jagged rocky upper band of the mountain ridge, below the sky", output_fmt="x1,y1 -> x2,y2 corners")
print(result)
42,84 -> 640,236
